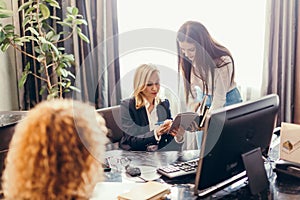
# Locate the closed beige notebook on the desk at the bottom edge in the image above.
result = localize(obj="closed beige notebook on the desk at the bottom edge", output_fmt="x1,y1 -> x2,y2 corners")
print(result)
118,181 -> 171,200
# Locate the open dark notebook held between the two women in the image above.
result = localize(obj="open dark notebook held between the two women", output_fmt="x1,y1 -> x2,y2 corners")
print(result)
169,95 -> 209,132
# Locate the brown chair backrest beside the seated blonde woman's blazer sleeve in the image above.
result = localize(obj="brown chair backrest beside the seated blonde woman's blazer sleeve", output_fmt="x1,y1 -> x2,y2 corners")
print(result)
97,105 -> 123,143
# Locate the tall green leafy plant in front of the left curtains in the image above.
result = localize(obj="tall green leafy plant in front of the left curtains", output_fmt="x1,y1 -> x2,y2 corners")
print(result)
0,0 -> 89,99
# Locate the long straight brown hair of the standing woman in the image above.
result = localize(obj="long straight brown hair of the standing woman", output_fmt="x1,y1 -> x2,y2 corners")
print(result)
177,21 -> 234,102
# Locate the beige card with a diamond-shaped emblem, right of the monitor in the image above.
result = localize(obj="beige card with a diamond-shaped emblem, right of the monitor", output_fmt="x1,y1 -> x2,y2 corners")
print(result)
280,122 -> 300,164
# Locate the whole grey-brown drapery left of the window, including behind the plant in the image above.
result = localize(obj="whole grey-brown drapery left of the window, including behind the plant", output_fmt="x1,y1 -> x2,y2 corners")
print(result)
10,0 -> 121,110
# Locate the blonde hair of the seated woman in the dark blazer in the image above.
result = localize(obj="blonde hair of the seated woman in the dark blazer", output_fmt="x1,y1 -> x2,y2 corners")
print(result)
133,63 -> 159,109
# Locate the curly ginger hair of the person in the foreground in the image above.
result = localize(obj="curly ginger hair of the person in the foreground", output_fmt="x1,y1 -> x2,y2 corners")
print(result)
3,99 -> 107,200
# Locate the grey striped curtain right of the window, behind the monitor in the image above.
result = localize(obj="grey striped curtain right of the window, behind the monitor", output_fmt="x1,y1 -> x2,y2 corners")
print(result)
261,0 -> 299,125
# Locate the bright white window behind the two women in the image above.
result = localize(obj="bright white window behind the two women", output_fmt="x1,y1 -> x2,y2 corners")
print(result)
118,0 -> 266,111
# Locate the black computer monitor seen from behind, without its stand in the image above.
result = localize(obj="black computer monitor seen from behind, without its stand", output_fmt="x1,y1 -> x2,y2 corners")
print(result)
195,94 -> 279,196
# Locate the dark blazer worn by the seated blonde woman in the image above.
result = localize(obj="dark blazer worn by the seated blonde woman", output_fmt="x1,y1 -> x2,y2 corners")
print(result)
119,98 -> 181,151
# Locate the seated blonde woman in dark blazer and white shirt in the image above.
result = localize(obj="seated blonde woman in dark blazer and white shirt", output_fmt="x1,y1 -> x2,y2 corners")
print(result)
120,64 -> 184,151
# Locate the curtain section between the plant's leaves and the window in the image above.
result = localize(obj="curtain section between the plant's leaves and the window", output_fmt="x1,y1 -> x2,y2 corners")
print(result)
67,0 -> 121,108
